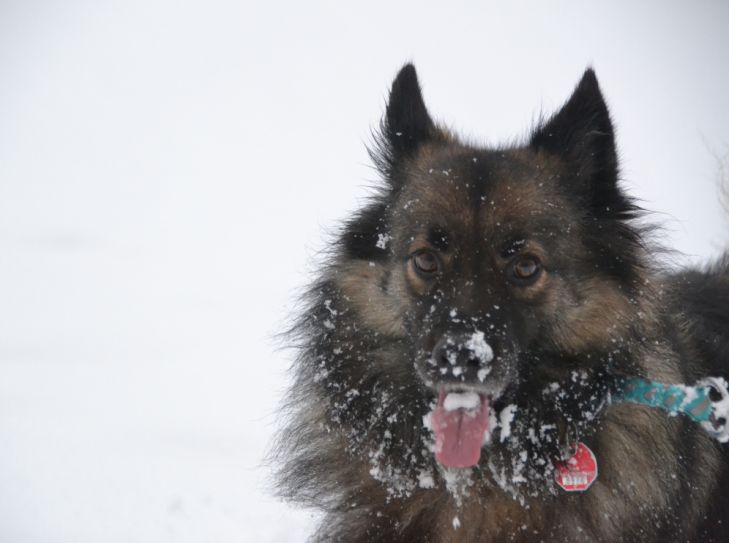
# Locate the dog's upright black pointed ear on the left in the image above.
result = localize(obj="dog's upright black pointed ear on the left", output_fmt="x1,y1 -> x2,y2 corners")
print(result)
383,64 -> 435,162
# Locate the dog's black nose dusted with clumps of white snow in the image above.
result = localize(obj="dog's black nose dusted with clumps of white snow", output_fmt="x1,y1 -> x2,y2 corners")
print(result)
429,332 -> 494,382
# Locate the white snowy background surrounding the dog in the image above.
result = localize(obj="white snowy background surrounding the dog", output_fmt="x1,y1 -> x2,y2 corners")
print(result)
0,0 -> 729,543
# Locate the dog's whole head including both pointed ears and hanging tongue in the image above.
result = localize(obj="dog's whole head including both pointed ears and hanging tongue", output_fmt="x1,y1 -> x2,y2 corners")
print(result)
328,66 -> 640,488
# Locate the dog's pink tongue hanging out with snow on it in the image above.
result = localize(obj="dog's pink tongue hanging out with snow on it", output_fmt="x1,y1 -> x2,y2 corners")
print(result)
431,392 -> 489,468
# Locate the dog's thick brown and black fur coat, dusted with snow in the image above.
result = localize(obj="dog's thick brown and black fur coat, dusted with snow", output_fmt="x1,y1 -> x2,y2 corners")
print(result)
276,65 -> 729,542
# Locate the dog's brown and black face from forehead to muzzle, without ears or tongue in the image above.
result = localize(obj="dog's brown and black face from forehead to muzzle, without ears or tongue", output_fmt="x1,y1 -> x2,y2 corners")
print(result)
391,146 -> 585,388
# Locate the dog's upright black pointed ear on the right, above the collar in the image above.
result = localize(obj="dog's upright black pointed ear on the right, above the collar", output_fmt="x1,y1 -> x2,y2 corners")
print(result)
530,69 -> 626,215
